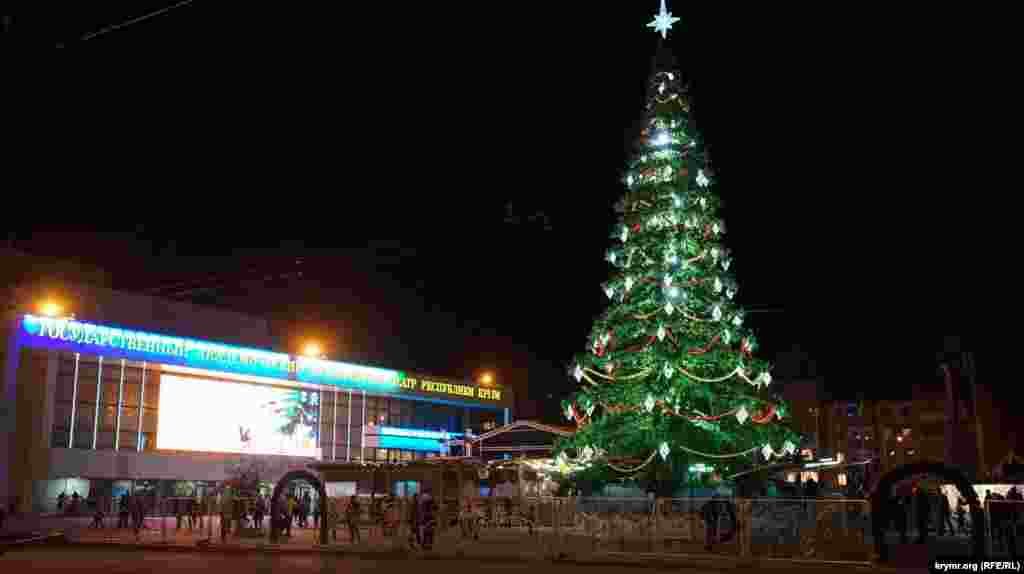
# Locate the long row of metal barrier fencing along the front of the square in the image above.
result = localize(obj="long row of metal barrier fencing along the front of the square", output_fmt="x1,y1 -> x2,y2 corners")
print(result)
46,496 -> 1024,562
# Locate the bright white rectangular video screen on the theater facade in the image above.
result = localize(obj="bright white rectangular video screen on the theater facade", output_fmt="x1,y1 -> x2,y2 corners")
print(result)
157,374 -> 321,458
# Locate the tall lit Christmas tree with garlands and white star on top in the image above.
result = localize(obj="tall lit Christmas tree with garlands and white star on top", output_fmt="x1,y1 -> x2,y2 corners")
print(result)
560,0 -> 799,477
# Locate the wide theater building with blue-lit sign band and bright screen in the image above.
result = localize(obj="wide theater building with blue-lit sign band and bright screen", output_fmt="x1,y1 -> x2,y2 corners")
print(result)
0,288 -> 513,512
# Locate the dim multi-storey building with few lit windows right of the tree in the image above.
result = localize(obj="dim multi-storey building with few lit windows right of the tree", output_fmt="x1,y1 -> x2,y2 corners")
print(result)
784,361 -> 1003,488
